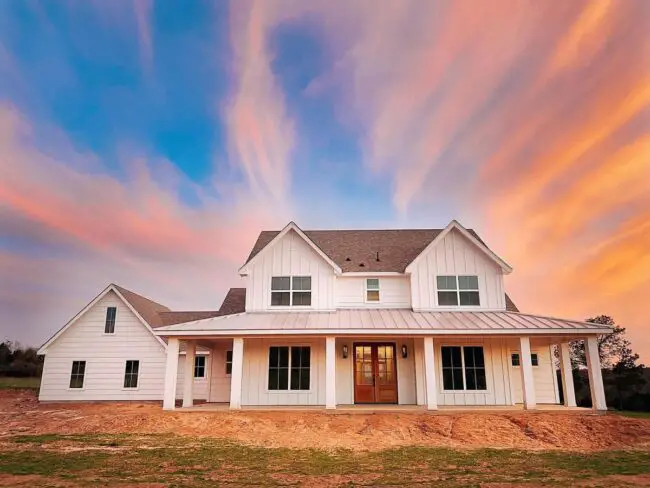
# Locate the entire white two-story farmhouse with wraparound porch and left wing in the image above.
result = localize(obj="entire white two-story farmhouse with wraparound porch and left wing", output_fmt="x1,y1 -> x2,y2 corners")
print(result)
39,221 -> 610,410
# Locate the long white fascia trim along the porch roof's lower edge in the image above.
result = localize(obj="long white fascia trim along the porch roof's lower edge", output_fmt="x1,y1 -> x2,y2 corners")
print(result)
155,329 -> 611,338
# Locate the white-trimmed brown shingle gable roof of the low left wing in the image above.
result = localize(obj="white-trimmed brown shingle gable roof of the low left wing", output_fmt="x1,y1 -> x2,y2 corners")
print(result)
38,283 -> 169,355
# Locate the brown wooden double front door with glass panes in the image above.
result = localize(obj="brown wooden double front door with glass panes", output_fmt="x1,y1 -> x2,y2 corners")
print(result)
354,343 -> 397,403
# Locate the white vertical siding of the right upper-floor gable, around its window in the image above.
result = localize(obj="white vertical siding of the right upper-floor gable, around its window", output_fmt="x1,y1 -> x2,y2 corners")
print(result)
411,230 -> 506,311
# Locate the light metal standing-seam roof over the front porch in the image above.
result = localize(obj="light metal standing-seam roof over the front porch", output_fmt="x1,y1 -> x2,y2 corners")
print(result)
155,309 -> 610,336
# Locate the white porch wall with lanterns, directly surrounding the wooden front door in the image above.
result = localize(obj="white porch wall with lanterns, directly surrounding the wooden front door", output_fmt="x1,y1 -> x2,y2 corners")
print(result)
336,337 -> 416,405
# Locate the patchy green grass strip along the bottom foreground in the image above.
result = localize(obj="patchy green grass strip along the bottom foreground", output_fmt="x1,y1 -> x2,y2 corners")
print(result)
0,434 -> 650,487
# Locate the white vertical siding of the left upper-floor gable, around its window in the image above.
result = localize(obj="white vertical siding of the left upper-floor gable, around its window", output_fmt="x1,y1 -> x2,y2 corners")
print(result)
246,230 -> 335,312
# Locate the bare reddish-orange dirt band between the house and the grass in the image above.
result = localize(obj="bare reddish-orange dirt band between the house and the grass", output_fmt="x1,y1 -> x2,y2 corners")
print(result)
0,390 -> 650,451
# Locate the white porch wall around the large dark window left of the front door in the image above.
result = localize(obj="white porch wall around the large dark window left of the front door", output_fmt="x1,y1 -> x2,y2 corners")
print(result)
242,338 -> 325,405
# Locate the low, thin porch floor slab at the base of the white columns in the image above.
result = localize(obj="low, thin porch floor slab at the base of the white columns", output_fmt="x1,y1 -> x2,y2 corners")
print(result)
175,403 -> 595,415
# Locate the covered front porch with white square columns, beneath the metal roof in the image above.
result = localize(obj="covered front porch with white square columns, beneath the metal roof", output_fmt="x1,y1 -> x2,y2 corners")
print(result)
158,334 -> 606,414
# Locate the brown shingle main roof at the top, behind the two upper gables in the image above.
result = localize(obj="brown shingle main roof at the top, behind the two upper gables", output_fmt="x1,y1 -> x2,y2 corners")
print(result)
246,229 -> 485,273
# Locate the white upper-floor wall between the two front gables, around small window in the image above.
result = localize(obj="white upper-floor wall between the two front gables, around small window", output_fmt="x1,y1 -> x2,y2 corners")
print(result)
336,276 -> 411,308
